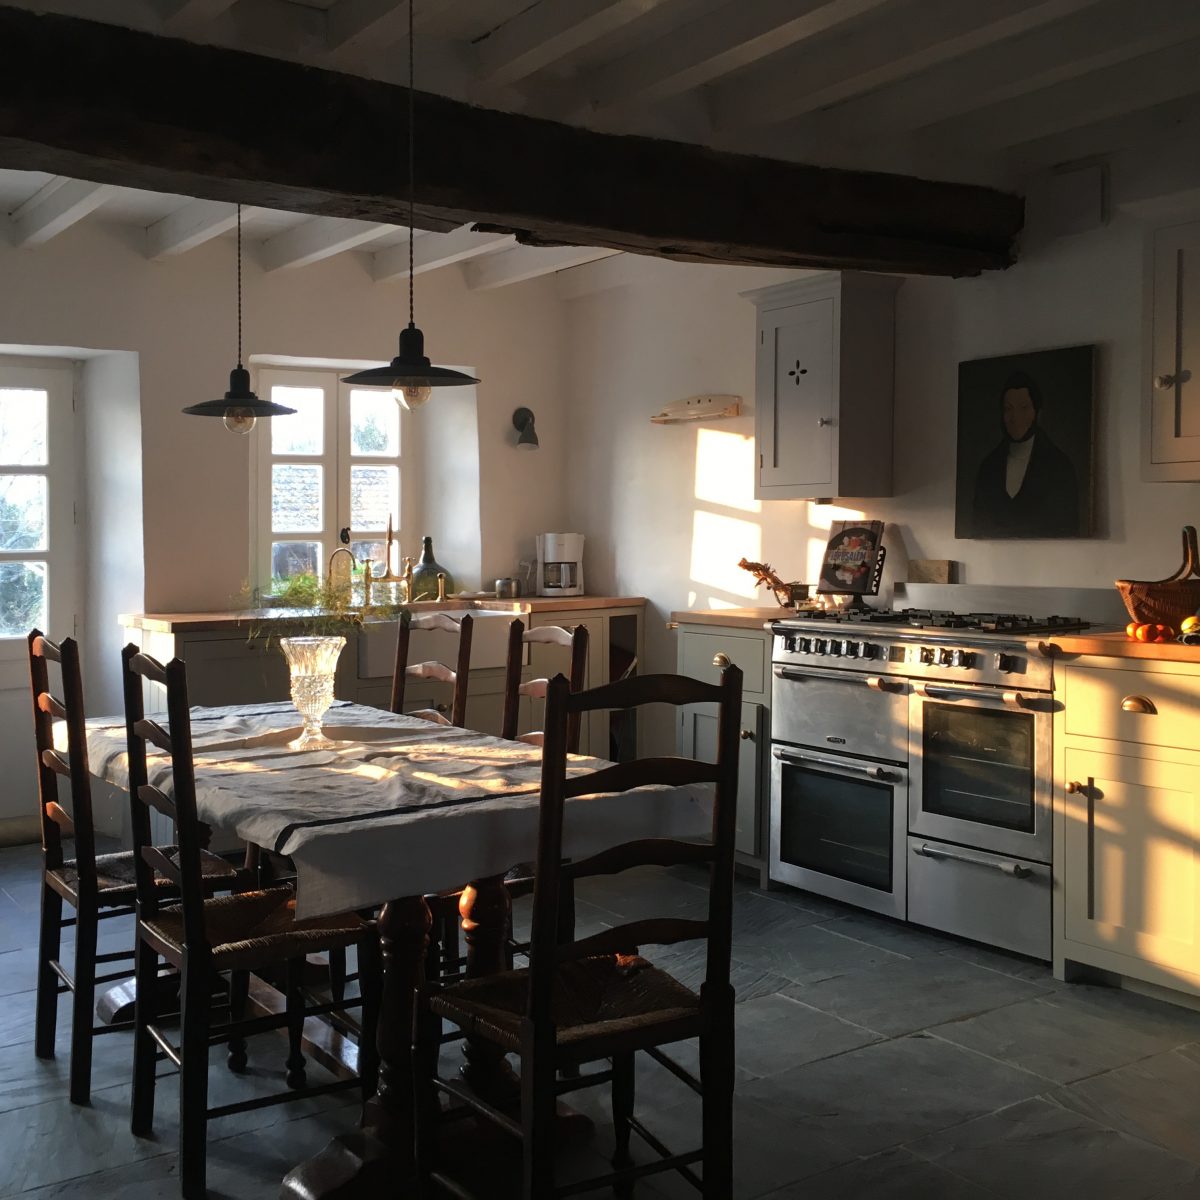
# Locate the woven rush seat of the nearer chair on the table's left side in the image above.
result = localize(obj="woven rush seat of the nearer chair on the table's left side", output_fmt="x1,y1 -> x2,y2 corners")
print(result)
143,888 -> 366,971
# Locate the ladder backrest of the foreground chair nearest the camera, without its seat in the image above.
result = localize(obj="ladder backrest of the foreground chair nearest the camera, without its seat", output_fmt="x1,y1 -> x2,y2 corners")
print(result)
526,666 -> 742,1036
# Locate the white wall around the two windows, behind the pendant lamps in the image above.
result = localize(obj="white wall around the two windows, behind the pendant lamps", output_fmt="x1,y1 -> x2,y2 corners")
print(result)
0,222 -> 565,611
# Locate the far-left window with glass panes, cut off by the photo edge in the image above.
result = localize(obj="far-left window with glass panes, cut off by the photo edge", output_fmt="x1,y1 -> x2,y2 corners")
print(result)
0,359 -> 76,643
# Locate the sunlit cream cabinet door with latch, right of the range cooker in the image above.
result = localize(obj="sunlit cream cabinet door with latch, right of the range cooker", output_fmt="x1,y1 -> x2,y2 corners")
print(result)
1062,746 -> 1200,974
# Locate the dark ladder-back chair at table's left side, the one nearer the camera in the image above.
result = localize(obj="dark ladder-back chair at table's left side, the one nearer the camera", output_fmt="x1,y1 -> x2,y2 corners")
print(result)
121,646 -> 380,1200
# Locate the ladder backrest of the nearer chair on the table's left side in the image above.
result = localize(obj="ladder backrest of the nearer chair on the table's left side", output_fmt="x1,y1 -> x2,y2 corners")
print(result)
121,644 -> 208,931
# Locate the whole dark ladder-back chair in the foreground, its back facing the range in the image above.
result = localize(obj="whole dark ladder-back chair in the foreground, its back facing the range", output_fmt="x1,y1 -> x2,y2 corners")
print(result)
414,666 -> 742,1200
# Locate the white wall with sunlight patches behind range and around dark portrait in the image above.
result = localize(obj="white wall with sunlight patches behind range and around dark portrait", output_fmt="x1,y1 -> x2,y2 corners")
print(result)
563,218 -> 1200,739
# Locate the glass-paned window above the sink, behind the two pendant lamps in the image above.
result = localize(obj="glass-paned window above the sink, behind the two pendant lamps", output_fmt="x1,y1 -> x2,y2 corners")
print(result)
253,368 -> 401,587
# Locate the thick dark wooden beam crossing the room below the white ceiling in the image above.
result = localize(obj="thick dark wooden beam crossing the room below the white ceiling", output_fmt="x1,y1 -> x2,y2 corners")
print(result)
0,6 -> 1024,275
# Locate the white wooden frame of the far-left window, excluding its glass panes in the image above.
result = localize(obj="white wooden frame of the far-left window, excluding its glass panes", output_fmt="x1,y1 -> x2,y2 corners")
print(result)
0,356 -> 79,664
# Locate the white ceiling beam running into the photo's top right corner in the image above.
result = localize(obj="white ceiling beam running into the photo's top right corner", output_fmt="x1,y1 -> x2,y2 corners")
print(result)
787,0 -> 1200,157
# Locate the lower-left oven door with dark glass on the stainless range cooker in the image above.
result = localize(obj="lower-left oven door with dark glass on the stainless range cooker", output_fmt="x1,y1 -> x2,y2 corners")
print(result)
770,744 -> 908,919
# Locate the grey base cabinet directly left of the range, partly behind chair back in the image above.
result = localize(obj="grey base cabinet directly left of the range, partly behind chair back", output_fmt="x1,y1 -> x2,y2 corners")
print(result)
673,613 -> 770,882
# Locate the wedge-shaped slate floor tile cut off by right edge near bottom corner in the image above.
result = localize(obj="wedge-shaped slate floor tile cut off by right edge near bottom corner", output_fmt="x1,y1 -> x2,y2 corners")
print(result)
1054,1045 -> 1200,1163
